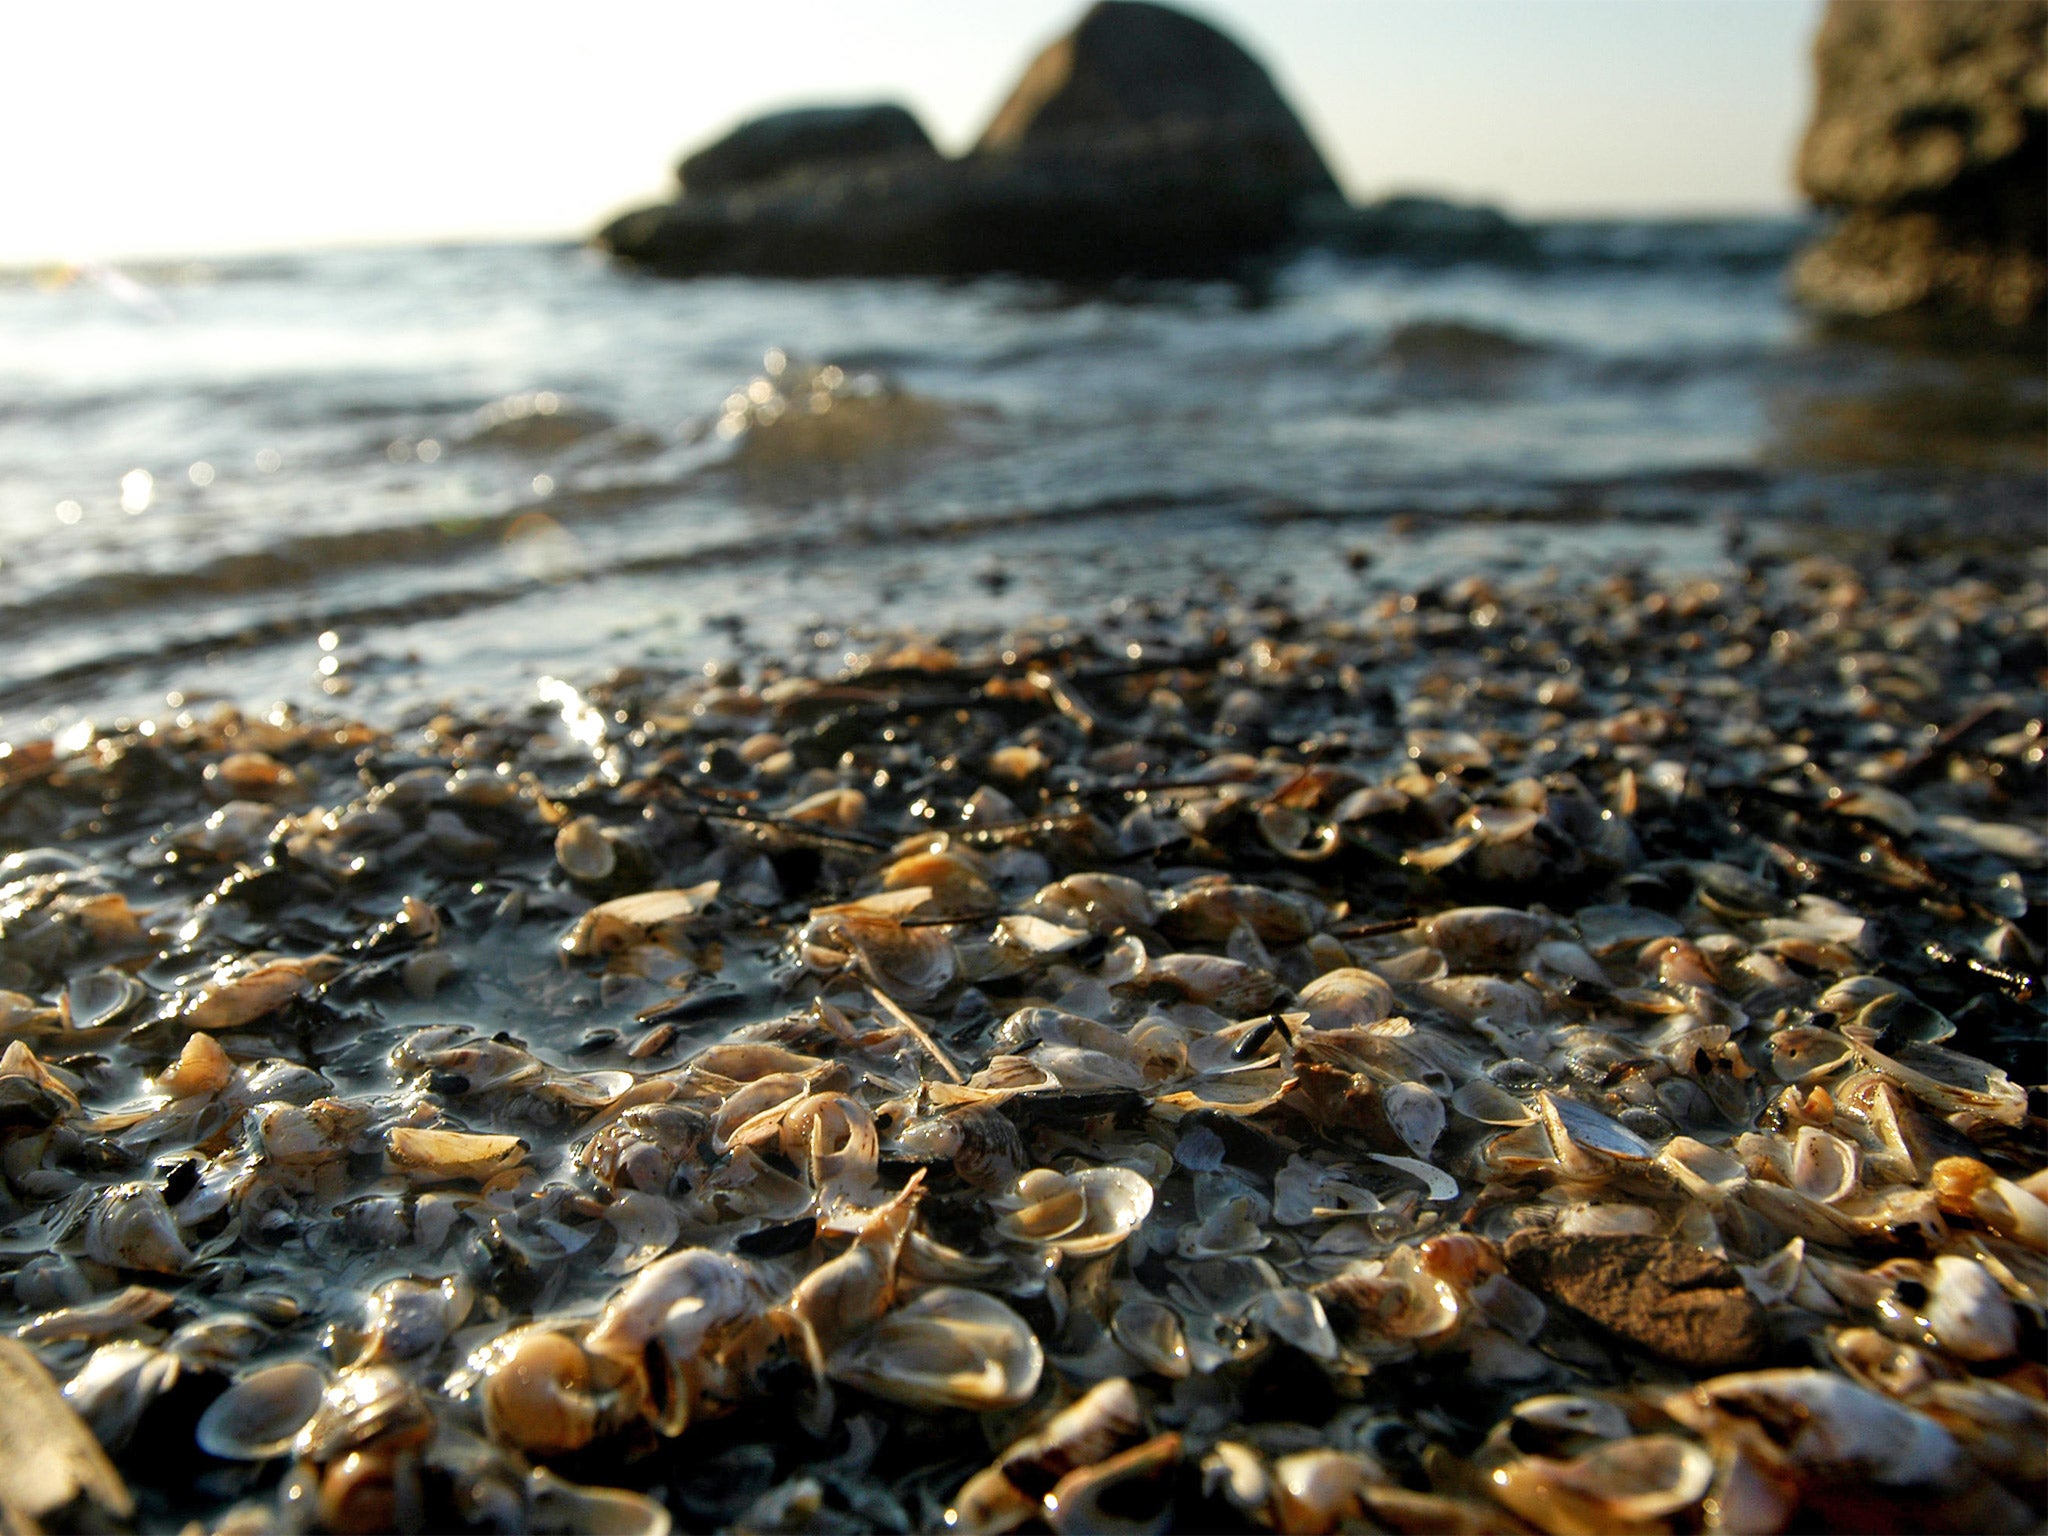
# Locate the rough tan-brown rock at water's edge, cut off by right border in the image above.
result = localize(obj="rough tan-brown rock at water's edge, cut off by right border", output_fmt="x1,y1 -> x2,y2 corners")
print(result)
1792,0 -> 2048,326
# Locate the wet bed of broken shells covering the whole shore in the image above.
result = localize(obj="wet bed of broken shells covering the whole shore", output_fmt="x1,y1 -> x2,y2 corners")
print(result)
0,557 -> 2048,1536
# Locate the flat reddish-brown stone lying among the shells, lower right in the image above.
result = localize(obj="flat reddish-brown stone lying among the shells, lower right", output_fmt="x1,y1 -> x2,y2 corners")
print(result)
1507,1231 -> 1769,1370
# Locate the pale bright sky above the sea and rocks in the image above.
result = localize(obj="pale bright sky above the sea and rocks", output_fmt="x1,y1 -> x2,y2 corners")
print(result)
0,0 -> 1819,264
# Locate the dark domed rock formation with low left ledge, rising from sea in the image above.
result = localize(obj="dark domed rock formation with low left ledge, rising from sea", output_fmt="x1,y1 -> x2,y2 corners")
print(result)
598,0 -> 1337,281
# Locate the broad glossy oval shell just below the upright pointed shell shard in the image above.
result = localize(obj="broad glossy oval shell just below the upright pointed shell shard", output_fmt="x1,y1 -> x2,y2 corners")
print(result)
825,1286 -> 1044,1413
